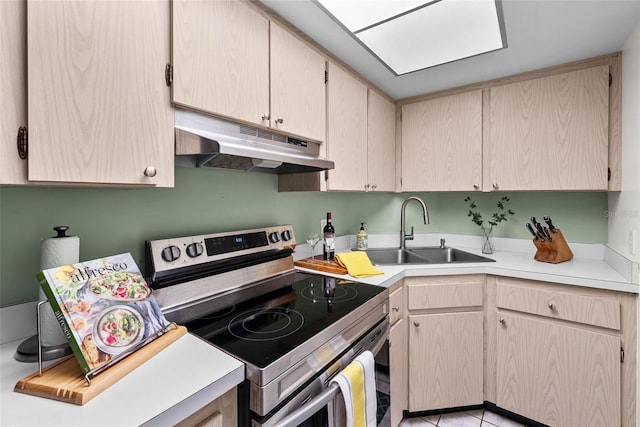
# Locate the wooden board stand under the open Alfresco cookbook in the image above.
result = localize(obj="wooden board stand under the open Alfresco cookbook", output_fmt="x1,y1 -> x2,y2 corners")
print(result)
13,326 -> 187,405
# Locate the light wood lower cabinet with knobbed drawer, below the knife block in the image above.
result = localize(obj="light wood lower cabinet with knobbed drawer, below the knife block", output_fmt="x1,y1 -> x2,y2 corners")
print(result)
485,276 -> 639,427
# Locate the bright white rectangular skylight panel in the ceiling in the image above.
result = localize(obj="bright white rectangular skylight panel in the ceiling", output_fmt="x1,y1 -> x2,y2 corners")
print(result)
316,0 -> 506,75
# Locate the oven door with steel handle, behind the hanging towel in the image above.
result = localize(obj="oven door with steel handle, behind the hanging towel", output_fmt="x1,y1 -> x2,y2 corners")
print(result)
260,319 -> 389,427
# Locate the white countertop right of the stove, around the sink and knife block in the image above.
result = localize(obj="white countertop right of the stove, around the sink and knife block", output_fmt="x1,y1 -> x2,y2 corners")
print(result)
298,241 -> 640,293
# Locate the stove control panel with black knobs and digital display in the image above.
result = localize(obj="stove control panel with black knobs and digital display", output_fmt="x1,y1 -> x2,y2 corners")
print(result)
146,225 -> 296,271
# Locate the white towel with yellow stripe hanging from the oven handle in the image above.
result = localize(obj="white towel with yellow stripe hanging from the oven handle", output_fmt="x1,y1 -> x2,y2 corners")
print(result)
331,350 -> 378,427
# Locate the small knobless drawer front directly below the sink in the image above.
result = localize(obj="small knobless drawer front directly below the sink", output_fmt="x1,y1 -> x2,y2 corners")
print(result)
405,279 -> 484,310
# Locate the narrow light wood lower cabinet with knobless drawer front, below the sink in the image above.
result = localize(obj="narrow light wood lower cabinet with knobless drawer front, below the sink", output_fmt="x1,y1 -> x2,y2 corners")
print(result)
404,275 -> 484,412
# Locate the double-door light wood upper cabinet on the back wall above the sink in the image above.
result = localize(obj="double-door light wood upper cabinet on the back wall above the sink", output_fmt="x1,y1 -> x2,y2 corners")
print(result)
398,53 -> 622,191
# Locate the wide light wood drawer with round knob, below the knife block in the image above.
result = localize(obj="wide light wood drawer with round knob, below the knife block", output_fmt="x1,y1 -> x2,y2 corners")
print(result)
497,283 -> 620,330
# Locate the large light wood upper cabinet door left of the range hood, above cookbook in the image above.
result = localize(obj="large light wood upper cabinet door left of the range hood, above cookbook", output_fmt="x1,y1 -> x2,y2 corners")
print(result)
27,0 -> 174,186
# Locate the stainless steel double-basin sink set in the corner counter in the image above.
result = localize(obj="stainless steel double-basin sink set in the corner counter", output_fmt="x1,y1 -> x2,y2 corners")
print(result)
366,246 -> 495,265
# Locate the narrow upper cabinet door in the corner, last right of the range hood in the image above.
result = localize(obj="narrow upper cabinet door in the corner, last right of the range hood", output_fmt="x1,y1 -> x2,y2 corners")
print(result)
367,89 -> 396,191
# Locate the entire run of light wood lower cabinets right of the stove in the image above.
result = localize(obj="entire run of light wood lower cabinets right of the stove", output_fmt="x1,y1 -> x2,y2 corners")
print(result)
389,274 -> 640,427
